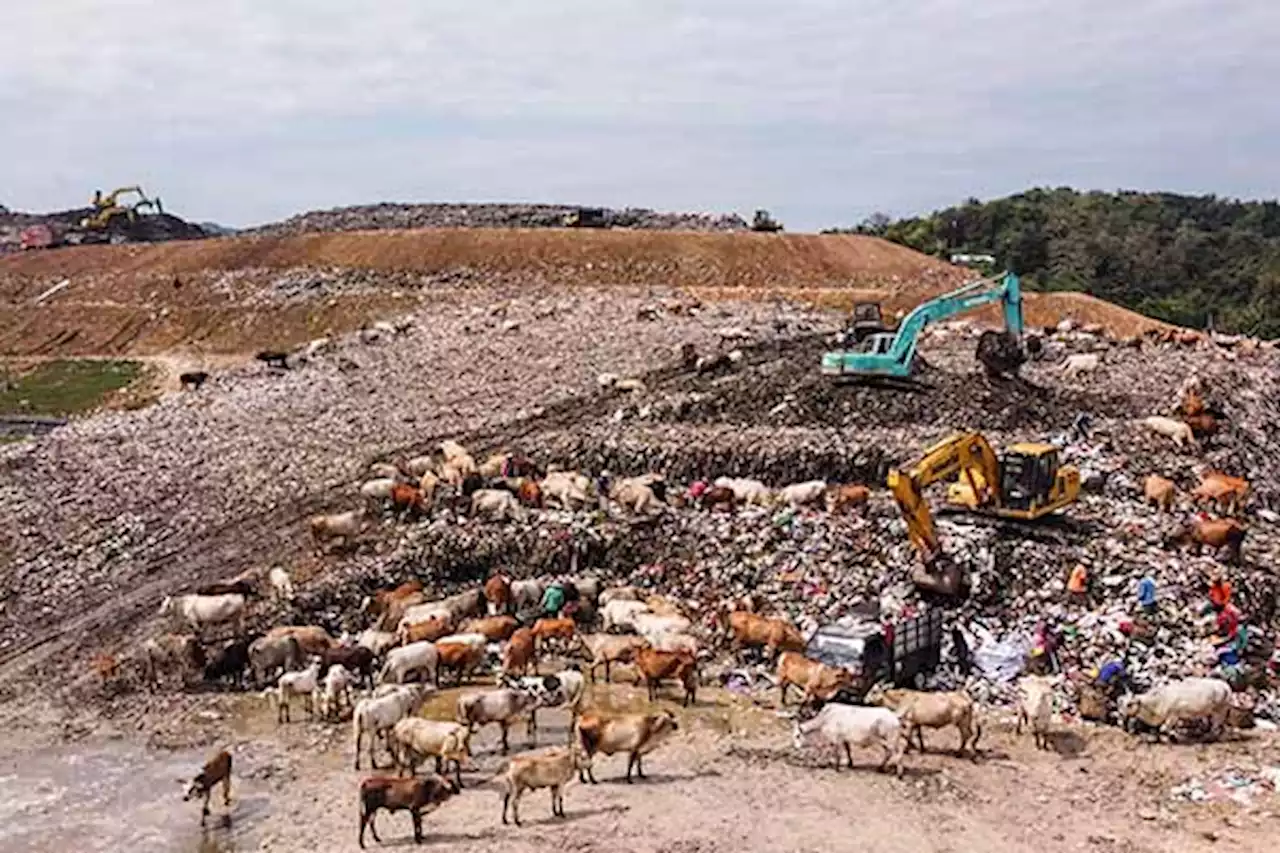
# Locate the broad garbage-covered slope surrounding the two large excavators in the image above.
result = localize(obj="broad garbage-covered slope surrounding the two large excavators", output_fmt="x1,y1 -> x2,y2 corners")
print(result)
0,286 -> 1280,721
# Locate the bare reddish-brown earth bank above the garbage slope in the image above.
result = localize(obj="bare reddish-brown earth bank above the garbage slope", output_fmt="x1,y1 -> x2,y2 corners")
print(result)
0,229 -> 1158,356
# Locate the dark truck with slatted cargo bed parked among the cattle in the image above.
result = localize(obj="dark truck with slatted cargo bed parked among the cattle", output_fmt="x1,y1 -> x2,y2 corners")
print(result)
805,608 -> 946,702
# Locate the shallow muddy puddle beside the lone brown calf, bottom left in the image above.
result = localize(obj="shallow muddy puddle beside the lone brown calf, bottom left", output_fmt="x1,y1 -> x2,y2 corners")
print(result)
0,744 -> 266,853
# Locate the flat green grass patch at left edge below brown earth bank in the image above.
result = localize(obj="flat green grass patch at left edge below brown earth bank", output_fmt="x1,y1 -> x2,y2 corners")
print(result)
0,359 -> 142,416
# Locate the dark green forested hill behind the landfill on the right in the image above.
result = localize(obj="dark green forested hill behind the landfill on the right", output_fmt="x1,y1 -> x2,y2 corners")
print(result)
834,188 -> 1280,338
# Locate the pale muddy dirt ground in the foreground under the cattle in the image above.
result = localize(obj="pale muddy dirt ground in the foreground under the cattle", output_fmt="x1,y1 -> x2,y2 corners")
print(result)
0,685 -> 1280,853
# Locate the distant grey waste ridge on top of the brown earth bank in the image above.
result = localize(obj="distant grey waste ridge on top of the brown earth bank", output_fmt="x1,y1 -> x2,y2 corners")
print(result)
241,204 -> 750,237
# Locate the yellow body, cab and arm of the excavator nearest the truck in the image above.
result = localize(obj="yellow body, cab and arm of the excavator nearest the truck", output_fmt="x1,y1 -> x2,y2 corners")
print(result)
888,433 -> 1080,566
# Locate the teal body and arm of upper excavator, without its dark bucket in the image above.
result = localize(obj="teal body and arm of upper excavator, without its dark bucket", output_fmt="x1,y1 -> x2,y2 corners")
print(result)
822,273 -> 1023,378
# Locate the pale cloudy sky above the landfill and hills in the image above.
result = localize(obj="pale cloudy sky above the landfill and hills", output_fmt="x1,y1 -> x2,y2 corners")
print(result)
0,0 -> 1280,231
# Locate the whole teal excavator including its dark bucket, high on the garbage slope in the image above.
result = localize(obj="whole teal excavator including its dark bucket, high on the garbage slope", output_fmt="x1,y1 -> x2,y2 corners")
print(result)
822,273 -> 1027,379
